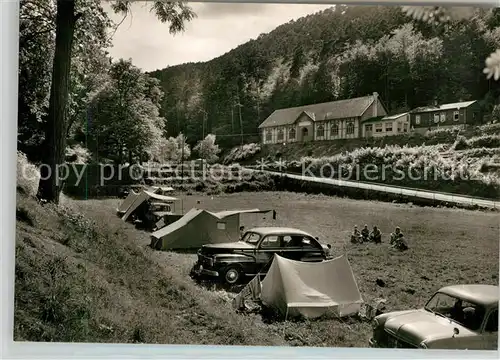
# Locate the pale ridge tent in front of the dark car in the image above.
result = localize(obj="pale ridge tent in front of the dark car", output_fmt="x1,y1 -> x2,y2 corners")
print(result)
233,255 -> 363,318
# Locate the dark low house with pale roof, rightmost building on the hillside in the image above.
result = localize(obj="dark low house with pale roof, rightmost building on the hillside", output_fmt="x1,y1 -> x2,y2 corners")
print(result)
410,100 -> 482,134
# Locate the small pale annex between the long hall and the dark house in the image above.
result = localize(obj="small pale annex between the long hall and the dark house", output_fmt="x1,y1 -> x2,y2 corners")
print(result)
362,112 -> 410,138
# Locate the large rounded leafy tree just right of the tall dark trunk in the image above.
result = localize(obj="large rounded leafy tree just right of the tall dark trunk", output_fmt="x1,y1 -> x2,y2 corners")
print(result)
86,59 -> 165,162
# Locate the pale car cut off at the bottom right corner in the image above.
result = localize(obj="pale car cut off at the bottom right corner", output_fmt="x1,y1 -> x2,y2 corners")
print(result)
369,284 -> 499,350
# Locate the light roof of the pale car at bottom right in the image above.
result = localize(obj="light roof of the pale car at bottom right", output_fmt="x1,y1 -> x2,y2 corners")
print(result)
439,284 -> 500,306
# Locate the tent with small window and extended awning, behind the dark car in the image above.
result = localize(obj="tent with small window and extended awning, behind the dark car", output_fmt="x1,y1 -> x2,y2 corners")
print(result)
151,209 -> 272,250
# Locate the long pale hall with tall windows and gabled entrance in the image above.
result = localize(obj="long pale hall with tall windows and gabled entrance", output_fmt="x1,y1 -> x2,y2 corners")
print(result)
259,92 -> 387,144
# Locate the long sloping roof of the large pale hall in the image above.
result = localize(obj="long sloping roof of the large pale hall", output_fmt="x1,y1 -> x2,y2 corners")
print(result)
259,93 -> 378,128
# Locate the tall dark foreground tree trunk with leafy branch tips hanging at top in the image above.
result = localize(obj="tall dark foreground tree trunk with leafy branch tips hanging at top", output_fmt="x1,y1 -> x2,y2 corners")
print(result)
37,0 -> 195,204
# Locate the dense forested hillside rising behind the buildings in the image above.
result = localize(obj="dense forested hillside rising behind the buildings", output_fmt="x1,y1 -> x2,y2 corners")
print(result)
150,5 -> 500,147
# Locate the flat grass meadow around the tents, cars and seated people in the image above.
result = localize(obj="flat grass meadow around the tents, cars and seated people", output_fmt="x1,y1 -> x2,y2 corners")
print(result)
79,192 -> 499,347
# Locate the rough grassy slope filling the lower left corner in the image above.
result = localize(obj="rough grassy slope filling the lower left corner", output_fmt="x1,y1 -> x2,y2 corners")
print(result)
14,188 -> 285,345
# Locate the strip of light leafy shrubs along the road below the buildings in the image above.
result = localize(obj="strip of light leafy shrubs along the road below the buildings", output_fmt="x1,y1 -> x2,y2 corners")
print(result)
264,145 -> 500,198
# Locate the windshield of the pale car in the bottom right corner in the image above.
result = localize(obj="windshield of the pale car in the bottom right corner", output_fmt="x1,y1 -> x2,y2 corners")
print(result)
425,292 -> 486,331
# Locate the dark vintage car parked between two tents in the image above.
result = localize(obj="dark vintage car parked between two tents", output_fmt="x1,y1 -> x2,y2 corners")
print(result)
191,227 -> 331,285
